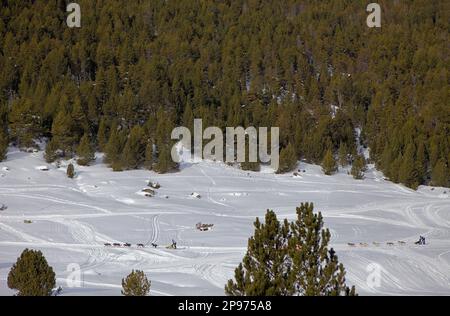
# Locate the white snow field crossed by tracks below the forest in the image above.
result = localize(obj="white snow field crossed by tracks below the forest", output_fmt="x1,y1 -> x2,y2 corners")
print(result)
0,149 -> 450,296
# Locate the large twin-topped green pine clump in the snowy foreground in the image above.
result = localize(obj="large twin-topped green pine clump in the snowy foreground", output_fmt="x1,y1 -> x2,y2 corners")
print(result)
225,203 -> 356,296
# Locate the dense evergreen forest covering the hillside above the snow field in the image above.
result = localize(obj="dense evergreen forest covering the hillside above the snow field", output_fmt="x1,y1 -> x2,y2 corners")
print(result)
0,0 -> 450,188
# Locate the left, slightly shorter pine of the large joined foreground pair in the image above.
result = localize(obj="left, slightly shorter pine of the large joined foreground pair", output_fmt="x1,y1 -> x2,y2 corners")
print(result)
225,211 -> 292,296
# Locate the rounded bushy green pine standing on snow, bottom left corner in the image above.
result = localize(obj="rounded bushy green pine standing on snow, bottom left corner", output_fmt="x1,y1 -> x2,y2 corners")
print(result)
8,249 -> 56,296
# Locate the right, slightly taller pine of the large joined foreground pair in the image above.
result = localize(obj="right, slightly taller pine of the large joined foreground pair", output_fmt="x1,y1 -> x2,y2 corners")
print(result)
289,203 -> 355,296
